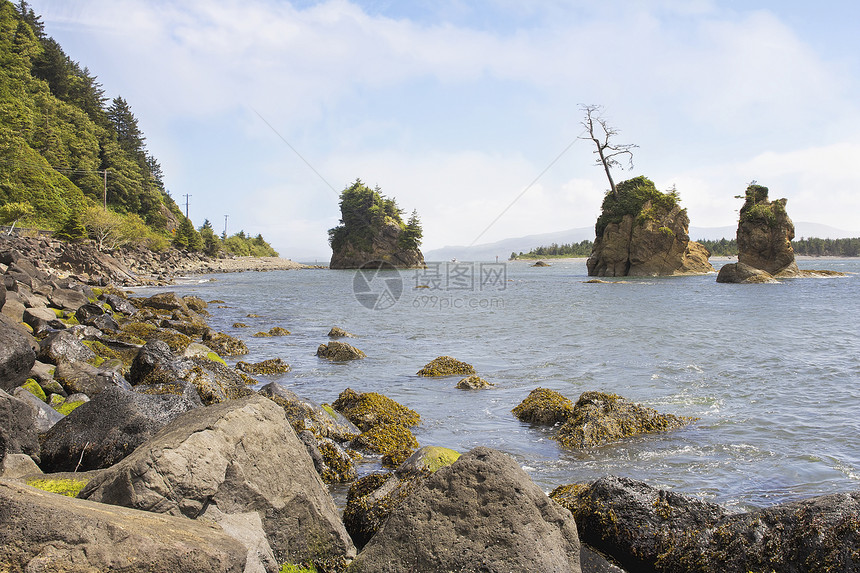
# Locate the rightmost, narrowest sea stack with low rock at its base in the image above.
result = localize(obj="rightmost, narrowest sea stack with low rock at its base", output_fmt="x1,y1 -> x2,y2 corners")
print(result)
717,185 -> 801,283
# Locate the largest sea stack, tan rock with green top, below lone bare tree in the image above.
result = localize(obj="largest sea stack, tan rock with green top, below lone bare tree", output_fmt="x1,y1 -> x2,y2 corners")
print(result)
587,176 -> 714,277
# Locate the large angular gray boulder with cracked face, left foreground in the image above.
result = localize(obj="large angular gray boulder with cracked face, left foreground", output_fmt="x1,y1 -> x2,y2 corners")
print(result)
80,395 -> 355,563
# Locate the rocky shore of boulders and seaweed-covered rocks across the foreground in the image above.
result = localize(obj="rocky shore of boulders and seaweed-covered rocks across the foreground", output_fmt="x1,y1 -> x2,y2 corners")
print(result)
0,235 -> 860,573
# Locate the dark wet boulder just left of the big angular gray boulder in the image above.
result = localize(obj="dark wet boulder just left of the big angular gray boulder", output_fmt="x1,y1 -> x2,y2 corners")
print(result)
41,386 -> 197,472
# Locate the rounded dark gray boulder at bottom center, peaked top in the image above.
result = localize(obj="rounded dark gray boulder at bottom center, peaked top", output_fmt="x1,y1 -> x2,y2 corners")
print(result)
348,447 -> 580,573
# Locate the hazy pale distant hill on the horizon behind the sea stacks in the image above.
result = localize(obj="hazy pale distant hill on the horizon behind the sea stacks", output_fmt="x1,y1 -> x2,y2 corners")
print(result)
424,222 -> 860,261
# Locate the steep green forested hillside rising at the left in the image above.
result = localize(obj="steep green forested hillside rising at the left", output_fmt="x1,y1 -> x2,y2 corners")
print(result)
0,0 -> 181,232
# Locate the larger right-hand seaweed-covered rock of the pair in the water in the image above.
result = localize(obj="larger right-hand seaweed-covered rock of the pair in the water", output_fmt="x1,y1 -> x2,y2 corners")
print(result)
555,392 -> 695,448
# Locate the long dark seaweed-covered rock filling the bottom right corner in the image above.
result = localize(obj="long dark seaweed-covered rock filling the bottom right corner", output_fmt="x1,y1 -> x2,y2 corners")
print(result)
562,476 -> 860,573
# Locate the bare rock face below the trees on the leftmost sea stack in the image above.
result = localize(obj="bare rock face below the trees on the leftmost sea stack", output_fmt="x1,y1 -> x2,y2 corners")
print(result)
329,221 -> 424,269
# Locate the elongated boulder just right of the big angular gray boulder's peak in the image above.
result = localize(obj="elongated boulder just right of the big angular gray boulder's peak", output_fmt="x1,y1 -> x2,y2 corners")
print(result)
259,382 -> 361,442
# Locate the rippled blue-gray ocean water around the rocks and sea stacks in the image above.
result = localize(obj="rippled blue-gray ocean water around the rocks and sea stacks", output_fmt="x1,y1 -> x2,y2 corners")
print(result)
144,259 -> 860,510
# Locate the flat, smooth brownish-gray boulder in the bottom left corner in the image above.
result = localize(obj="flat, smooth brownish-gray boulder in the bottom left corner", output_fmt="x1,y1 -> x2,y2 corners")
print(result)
0,480 -> 247,573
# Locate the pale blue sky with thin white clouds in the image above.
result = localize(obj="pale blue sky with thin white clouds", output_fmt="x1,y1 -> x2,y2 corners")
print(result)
31,0 -> 860,262
